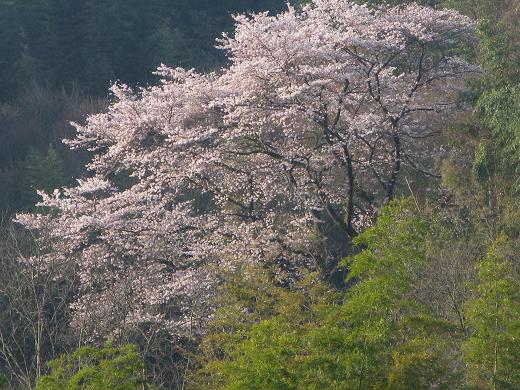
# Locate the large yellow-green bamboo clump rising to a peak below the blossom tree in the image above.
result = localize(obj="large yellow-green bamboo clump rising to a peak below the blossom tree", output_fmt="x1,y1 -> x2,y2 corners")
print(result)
196,201 -> 456,389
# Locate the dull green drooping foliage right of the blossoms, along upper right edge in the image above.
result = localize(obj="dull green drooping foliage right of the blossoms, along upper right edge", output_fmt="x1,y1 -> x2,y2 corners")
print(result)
443,0 -> 520,235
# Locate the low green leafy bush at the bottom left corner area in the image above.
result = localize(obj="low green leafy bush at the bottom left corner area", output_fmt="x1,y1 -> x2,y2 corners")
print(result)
35,344 -> 155,390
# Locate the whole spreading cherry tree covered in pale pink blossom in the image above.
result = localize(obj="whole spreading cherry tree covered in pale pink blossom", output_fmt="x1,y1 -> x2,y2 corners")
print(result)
18,0 -> 475,338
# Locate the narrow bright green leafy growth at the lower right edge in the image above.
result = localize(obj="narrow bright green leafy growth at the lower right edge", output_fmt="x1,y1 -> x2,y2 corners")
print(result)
464,236 -> 520,389
